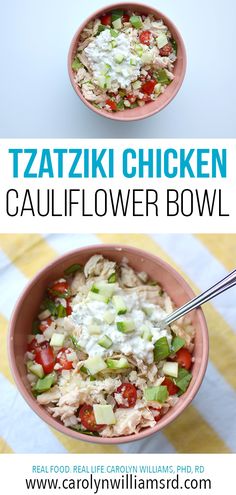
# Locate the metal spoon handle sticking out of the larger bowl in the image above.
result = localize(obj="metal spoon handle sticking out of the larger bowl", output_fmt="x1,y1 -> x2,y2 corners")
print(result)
160,269 -> 236,328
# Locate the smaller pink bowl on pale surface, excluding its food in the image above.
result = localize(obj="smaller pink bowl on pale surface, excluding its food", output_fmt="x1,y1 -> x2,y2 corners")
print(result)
68,2 -> 187,122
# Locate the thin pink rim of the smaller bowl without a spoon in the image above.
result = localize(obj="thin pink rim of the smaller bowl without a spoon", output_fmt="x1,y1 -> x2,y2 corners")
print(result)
67,2 -> 187,122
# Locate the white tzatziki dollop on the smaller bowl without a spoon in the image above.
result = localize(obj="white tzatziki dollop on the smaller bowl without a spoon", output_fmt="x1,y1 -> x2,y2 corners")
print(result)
84,29 -> 141,89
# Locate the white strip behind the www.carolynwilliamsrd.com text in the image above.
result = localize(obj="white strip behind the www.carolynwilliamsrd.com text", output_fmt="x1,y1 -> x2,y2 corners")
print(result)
0,454 -> 236,495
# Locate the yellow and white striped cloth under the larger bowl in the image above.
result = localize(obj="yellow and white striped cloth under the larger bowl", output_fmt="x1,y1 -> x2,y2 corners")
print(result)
0,234 -> 236,453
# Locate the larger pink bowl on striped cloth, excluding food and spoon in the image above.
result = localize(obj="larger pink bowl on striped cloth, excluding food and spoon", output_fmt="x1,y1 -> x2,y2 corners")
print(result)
8,244 -> 208,444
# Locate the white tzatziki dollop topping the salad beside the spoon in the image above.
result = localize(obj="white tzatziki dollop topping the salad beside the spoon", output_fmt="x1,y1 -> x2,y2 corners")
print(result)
69,289 -> 171,364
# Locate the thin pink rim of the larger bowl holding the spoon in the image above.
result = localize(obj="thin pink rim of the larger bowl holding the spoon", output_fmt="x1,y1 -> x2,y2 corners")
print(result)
7,243 -> 209,445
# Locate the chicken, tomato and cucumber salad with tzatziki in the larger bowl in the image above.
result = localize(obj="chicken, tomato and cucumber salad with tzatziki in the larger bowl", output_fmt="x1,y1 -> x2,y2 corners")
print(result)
24,253 -> 195,439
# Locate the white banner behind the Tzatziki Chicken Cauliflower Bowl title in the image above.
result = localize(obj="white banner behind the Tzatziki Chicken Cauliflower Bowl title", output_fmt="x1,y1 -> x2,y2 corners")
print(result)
0,139 -> 233,233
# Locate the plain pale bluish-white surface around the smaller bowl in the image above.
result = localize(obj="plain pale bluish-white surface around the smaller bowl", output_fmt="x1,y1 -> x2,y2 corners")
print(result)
0,0 -> 236,138
